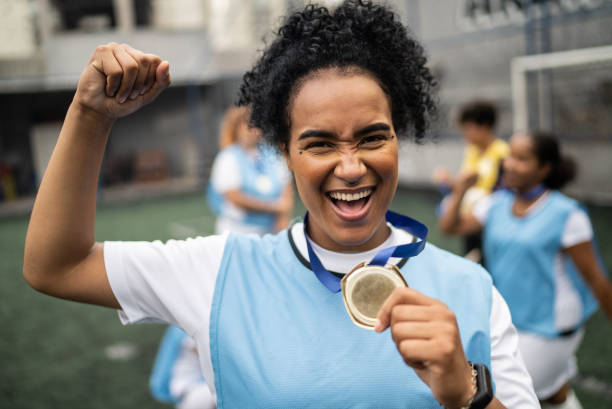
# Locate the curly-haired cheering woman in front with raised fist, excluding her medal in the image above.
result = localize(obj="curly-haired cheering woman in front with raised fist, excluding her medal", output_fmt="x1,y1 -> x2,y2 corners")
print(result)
24,1 -> 538,408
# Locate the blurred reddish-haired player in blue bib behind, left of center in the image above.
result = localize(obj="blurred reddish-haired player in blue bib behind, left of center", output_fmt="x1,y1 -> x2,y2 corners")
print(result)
207,103 -> 293,234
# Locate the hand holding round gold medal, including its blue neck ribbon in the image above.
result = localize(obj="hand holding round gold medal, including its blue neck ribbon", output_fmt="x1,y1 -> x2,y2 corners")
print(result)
304,211 -> 475,408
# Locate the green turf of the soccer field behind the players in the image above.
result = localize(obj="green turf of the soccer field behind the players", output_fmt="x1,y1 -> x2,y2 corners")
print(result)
0,190 -> 612,409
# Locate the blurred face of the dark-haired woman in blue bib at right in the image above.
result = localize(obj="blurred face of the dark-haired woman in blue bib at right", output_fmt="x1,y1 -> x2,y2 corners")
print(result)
503,134 -> 550,192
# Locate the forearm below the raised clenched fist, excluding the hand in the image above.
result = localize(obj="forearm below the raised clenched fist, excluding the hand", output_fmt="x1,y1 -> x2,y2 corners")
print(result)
24,102 -> 113,285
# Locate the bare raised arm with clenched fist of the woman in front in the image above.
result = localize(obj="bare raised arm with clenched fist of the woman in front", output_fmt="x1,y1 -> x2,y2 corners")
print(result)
23,43 -> 170,308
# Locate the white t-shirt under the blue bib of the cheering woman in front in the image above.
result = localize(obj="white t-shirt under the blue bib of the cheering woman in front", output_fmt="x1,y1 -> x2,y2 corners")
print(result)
104,223 -> 539,408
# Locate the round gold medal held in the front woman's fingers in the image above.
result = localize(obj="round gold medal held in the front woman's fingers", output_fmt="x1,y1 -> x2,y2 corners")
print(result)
340,263 -> 408,329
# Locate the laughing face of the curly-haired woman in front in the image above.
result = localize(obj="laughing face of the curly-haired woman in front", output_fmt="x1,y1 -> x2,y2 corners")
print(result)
285,69 -> 398,251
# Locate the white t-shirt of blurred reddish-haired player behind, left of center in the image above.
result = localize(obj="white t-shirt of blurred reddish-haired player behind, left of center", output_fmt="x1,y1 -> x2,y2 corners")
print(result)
210,149 -> 291,235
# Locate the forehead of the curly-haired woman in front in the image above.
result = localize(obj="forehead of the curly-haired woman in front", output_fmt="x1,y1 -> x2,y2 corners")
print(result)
289,69 -> 392,138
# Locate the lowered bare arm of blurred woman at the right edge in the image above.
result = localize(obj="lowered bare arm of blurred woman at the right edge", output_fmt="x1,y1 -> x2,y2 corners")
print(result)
565,241 -> 612,323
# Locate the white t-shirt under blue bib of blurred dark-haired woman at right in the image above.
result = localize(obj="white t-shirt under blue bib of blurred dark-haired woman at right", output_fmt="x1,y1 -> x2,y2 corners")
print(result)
472,191 -> 593,331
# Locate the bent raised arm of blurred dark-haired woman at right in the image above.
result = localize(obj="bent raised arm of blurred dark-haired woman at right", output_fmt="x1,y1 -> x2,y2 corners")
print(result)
438,172 -> 482,235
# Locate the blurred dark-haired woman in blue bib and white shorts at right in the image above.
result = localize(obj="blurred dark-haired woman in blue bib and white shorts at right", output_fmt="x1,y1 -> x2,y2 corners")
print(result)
440,134 -> 612,408
